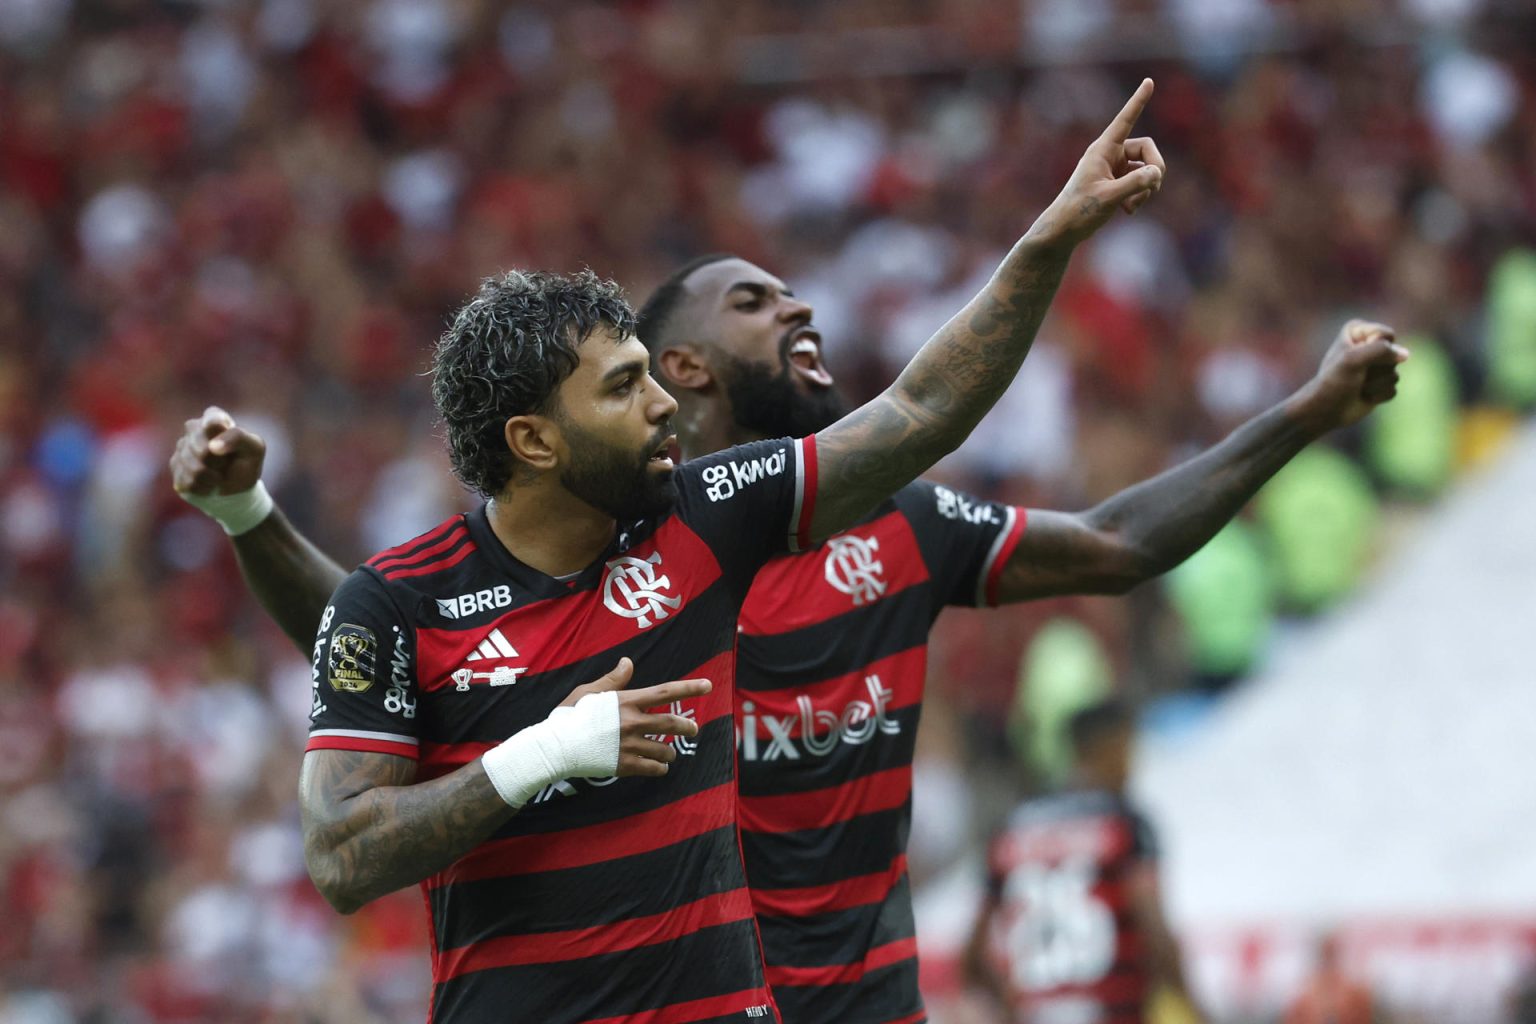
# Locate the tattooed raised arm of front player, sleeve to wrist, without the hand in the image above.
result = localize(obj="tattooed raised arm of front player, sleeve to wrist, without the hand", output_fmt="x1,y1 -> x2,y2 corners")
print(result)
814,235 -> 1069,537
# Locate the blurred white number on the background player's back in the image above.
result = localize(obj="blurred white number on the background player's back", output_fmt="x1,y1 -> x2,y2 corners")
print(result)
1006,858 -> 1115,992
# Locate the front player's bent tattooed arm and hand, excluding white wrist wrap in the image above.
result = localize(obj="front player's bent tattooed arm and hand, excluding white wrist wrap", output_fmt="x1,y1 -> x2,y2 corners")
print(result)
298,659 -> 710,913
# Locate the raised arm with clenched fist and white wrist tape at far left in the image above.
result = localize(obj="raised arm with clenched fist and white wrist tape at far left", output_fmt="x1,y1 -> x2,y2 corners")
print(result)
170,405 -> 347,654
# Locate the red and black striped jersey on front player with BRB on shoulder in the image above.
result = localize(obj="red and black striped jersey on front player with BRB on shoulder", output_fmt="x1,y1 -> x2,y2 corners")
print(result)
307,438 -> 816,1024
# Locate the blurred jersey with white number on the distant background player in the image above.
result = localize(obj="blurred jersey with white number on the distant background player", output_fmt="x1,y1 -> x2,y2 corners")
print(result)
988,789 -> 1157,1024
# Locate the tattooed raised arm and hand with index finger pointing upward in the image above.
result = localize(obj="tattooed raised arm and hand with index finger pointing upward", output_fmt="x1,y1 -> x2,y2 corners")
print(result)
811,80 -> 1164,539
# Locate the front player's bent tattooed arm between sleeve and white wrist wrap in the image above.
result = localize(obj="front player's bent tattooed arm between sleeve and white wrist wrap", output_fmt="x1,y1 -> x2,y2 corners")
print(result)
300,751 -> 516,913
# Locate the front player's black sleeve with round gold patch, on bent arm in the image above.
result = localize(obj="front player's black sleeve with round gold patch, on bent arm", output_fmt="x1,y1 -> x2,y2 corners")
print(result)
304,568 -> 419,760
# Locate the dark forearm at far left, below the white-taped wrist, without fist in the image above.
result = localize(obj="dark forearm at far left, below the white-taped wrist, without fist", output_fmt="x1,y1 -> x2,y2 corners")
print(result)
235,508 -> 347,657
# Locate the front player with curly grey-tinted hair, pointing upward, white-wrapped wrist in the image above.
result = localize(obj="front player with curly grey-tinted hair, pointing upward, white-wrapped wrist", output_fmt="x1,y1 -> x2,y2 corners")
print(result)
178,81 -> 1163,1024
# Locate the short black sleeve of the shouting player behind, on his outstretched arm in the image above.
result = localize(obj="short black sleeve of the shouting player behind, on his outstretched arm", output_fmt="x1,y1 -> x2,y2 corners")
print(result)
897,481 -> 1026,614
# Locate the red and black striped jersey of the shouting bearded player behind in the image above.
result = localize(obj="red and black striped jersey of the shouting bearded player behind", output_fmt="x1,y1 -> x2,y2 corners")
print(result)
737,481 -> 1025,1024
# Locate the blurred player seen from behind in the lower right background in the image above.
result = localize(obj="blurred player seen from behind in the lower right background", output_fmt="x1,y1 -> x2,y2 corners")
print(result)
965,702 -> 1198,1024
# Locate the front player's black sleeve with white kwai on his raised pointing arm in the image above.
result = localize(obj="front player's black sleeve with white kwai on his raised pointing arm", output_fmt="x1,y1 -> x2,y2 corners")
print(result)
677,438 -> 816,573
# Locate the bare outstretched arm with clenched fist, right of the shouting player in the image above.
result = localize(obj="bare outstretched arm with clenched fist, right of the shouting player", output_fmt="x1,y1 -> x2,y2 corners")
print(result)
998,321 -> 1409,602
